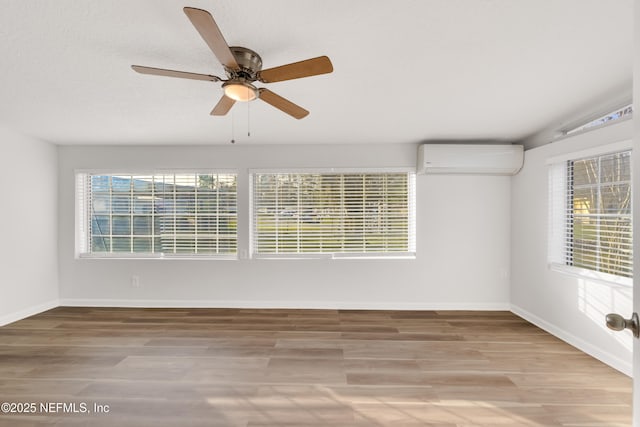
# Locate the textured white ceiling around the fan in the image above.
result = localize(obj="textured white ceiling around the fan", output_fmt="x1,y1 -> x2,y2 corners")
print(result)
0,0 -> 633,145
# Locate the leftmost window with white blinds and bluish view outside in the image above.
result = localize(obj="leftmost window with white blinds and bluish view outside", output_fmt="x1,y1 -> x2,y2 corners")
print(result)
76,172 -> 237,257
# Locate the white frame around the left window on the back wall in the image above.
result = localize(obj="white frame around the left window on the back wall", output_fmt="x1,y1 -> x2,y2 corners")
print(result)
74,168 -> 240,260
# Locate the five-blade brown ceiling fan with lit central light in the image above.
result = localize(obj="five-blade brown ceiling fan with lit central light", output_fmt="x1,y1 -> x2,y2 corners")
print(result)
131,7 -> 333,119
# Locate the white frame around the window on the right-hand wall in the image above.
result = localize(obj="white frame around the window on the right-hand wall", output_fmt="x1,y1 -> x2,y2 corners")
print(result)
546,140 -> 634,287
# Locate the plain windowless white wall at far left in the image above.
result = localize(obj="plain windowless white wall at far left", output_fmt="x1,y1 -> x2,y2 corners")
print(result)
0,127 -> 58,325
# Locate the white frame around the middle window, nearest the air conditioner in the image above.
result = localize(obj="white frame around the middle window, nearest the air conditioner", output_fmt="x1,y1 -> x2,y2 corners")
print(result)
248,167 -> 417,260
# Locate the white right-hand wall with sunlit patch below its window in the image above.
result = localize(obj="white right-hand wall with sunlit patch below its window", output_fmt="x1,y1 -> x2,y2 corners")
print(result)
511,121 -> 632,374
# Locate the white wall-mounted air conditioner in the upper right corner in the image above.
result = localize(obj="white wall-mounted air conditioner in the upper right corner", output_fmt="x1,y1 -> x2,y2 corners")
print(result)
418,144 -> 524,175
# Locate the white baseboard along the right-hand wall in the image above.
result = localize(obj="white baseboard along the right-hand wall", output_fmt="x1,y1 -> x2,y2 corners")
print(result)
511,304 -> 633,377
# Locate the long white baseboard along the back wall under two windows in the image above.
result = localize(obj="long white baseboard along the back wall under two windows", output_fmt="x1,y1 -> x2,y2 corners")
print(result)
60,298 -> 511,311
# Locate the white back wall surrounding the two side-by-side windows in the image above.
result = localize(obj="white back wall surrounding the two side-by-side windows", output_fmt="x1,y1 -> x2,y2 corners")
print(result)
59,144 -> 510,309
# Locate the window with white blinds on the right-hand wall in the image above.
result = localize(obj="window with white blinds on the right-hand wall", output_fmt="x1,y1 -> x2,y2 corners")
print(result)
550,150 -> 633,278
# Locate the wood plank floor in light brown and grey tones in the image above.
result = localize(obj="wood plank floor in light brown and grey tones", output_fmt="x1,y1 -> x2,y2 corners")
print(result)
0,307 -> 632,427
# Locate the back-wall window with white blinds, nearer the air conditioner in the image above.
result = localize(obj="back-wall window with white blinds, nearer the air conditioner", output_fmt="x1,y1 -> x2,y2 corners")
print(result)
252,172 -> 415,256
